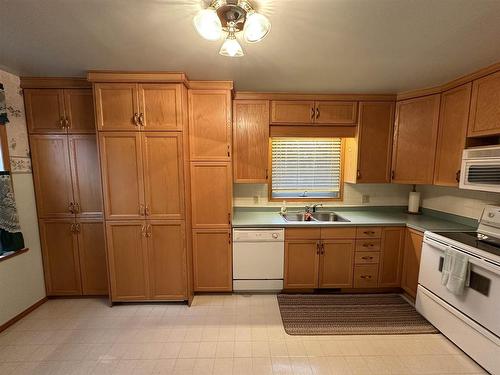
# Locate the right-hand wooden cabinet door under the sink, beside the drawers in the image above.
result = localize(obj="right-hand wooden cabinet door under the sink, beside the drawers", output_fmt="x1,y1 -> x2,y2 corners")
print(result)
319,239 -> 356,288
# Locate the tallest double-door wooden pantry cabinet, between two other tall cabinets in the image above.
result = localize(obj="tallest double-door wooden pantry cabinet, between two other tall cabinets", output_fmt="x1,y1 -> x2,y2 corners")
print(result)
88,72 -> 193,302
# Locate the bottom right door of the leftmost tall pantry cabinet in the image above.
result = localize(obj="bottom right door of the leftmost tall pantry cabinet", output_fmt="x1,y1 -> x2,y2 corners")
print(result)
76,219 -> 108,295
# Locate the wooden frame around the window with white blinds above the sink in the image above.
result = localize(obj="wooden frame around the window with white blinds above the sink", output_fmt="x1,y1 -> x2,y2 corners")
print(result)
267,137 -> 345,202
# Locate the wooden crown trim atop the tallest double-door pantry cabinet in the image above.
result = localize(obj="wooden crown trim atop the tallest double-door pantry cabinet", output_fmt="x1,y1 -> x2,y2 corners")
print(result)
87,70 -> 187,84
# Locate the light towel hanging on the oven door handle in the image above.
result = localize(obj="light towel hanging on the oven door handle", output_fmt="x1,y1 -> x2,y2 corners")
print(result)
441,247 -> 470,296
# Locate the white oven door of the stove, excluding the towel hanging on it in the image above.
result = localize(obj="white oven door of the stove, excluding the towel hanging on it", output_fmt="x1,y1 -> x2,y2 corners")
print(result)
418,237 -> 500,337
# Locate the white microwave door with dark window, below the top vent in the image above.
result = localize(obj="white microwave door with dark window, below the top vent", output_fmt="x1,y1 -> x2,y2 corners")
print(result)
459,158 -> 500,193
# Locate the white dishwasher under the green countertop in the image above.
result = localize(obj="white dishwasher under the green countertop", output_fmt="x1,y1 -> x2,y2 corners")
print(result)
233,228 -> 285,291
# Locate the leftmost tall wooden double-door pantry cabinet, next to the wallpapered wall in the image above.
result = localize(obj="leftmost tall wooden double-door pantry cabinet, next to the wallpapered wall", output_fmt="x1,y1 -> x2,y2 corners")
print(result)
21,78 -> 108,296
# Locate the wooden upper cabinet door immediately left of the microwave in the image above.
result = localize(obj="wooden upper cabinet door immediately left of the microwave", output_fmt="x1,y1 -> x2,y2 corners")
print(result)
434,83 -> 472,186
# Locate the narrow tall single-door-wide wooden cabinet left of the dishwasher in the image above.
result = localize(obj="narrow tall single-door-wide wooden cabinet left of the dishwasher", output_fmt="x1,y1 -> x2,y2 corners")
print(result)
189,81 -> 233,292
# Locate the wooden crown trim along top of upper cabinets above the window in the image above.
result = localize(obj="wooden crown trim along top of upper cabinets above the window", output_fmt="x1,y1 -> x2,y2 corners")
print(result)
234,91 -> 396,102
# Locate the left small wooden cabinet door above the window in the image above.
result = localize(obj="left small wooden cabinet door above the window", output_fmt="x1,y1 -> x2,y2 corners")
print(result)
271,100 -> 316,125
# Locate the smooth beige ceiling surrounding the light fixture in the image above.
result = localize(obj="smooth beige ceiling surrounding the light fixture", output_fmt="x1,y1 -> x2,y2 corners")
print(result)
0,0 -> 500,93
